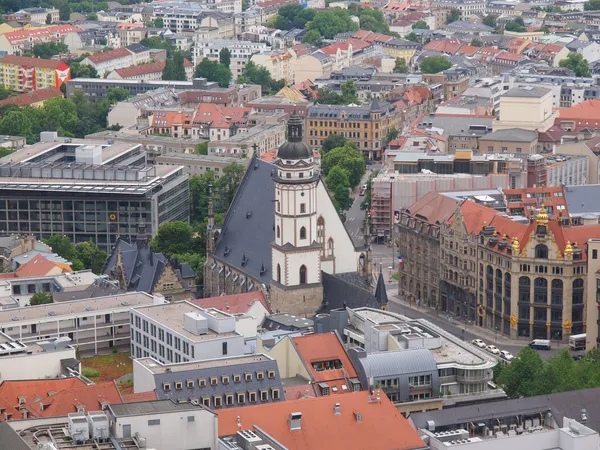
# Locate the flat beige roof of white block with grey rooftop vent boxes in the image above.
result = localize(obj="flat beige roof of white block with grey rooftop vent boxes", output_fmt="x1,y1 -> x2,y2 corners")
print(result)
135,302 -> 241,342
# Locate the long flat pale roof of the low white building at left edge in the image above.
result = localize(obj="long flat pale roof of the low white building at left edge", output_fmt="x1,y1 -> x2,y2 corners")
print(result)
0,292 -> 154,327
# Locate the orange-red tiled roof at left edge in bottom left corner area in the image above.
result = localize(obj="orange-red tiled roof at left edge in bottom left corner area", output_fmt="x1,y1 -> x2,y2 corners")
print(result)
0,378 -> 122,421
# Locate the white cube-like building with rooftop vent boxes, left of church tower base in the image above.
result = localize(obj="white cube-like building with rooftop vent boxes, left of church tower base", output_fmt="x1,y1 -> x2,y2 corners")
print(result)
131,302 -> 245,363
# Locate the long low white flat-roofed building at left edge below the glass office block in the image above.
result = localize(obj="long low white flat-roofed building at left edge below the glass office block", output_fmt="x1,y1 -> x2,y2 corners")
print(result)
0,292 -> 164,354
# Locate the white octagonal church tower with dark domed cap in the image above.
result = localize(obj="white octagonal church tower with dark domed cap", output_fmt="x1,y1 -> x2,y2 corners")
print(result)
270,115 -> 323,316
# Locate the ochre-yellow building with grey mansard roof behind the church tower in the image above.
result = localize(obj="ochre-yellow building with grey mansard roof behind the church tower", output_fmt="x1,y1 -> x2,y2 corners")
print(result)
306,99 -> 398,160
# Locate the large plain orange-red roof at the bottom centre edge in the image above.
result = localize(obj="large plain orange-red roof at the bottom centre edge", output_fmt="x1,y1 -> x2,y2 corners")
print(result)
216,391 -> 426,450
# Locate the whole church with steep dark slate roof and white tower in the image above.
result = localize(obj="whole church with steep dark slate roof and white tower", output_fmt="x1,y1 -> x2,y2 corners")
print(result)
204,115 -> 380,316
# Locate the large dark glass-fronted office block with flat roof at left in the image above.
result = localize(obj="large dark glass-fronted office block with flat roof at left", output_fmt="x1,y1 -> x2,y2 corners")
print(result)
0,133 -> 189,252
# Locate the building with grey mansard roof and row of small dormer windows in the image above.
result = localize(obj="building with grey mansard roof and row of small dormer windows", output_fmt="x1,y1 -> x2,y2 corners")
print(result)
133,355 -> 283,409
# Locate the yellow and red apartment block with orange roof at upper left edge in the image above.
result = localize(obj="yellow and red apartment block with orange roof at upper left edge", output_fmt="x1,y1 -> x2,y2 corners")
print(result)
0,55 -> 71,92
